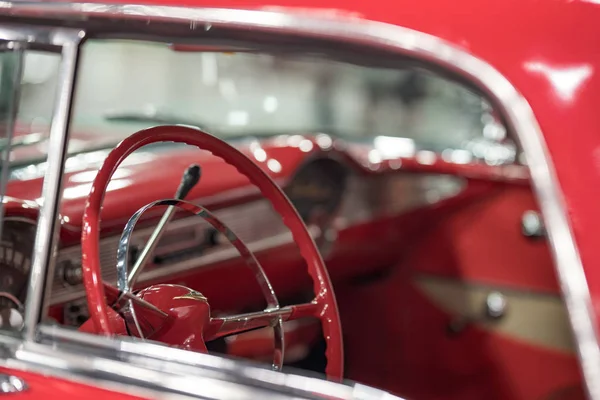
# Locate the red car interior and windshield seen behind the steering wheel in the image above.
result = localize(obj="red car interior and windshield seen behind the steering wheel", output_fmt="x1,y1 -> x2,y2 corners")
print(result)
0,39 -> 584,400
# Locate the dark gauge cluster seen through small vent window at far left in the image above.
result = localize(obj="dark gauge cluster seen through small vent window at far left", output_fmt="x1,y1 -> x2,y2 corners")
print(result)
0,220 -> 36,330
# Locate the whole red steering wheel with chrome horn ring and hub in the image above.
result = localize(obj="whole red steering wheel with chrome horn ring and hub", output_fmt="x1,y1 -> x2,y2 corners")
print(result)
81,125 -> 343,380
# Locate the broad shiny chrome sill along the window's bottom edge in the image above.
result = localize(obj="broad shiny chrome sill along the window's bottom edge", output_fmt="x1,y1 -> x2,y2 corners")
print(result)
24,325 -> 398,400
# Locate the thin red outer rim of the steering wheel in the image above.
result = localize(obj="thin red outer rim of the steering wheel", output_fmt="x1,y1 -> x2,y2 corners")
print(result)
81,125 -> 343,379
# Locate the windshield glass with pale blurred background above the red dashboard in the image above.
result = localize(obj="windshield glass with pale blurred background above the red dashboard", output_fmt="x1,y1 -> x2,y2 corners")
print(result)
11,40 -> 514,164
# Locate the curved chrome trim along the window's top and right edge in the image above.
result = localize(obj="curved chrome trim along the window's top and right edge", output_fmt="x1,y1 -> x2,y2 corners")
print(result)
0,2 -> 600,399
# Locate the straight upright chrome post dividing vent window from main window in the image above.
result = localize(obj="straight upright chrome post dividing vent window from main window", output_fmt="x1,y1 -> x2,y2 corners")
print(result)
24,31 -> 83,341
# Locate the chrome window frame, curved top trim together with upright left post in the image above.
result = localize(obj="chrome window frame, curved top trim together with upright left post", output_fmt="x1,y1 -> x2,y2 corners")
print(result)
0,3 -> 600,399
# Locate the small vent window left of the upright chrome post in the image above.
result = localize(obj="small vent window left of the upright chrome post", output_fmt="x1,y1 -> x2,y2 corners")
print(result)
0,47 -> 60,332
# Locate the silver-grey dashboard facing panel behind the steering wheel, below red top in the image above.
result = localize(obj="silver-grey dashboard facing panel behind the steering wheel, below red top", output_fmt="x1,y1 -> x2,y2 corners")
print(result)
51,158 -> 464,325
